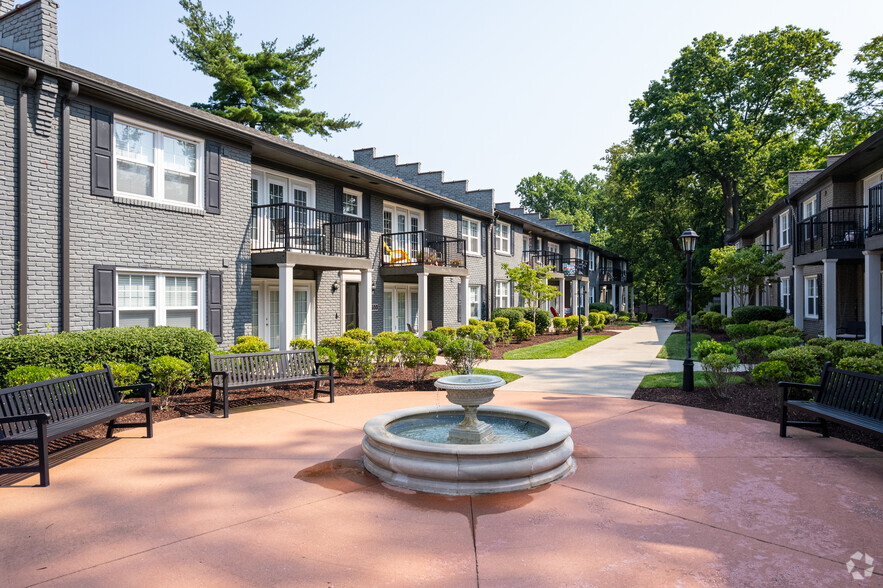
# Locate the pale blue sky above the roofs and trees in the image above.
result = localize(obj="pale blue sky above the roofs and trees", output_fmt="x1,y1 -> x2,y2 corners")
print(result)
58,0 -> 883,202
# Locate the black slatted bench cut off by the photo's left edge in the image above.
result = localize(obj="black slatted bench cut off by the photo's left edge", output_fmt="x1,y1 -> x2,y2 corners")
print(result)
0,364 -> 153,486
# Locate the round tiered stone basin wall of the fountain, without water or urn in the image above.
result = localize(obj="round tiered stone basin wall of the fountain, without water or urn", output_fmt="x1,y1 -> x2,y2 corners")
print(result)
362,406 -> 576,495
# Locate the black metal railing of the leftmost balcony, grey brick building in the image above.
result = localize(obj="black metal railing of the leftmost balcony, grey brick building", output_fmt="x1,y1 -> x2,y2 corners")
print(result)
251,203 -> 369,257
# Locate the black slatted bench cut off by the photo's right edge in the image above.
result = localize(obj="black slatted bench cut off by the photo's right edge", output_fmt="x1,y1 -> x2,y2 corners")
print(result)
779,362 -> 883,437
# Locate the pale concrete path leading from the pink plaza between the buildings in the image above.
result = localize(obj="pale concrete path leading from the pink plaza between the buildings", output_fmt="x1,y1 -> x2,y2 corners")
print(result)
481,323 -> 674,398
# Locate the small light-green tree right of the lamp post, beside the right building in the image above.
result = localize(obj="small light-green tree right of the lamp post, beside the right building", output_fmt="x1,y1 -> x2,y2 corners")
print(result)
702,244 -> 785,306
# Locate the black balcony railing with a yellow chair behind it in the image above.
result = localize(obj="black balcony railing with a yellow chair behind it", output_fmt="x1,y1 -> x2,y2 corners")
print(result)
380,231 -> 466,267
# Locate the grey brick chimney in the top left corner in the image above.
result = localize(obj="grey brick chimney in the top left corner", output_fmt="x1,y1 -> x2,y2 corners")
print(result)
0,0 -> 58,67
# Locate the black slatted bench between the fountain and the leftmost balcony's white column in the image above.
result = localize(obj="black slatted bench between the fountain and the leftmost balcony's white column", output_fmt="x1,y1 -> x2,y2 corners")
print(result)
209,347 -> 334,418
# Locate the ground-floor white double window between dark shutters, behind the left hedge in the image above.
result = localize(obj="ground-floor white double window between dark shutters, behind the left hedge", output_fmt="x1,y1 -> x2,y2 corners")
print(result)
117,270 -> 204,329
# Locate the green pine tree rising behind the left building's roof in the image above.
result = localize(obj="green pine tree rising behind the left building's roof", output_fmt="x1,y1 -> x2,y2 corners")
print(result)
170,0 -> 361,139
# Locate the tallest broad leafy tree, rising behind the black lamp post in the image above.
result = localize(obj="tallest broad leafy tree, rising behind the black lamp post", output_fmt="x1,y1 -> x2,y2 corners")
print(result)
630,26 -> 840,236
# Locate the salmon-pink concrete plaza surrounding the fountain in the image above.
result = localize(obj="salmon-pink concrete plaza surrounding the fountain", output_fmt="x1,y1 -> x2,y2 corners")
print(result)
0,390 -> 883,588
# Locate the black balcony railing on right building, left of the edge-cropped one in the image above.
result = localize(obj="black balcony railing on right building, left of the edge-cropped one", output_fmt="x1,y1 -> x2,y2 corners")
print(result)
797,206 -> 868,255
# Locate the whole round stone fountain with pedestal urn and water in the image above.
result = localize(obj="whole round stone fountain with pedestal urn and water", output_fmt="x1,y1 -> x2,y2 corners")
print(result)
362,374 -> 576,495
